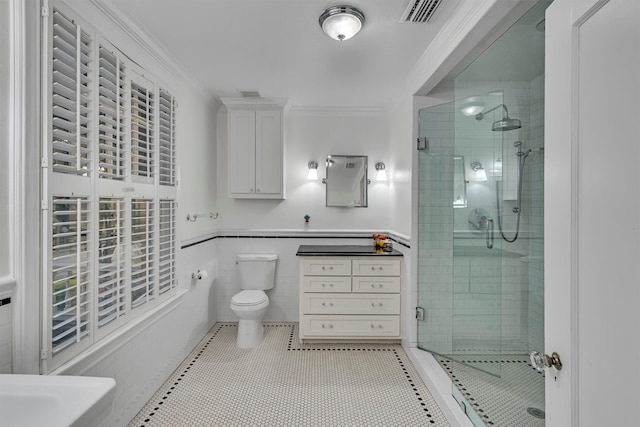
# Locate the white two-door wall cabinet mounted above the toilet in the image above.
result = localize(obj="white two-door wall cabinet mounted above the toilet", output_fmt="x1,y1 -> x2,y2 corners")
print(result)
222,98 -> 286,199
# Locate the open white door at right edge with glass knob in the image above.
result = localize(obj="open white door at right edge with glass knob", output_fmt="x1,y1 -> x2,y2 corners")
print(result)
545,0 -> 640,427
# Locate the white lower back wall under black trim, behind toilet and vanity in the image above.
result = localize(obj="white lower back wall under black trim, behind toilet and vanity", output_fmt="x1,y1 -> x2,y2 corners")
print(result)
215,233 -> 408,322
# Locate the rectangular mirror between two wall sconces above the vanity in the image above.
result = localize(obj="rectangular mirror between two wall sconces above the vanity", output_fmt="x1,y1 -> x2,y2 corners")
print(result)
325,155 -> 368,208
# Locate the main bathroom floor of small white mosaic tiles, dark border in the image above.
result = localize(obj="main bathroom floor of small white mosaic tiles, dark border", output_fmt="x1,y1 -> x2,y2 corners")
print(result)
129,323 -> 449,427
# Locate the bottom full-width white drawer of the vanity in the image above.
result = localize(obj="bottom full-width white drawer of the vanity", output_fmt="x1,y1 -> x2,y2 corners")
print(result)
301,315 -> 400,338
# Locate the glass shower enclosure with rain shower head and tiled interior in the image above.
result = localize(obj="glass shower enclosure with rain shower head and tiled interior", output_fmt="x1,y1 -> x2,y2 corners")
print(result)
418,1 -> 550,426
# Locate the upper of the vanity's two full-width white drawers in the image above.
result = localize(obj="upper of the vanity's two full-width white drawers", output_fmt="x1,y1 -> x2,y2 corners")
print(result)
302,293 -> 400,314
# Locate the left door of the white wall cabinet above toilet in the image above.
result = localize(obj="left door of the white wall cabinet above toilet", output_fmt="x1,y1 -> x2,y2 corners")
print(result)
227,110 -> 256,197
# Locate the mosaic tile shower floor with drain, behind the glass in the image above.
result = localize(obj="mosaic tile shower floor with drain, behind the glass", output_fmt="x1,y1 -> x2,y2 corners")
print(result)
436,355 -> 545,427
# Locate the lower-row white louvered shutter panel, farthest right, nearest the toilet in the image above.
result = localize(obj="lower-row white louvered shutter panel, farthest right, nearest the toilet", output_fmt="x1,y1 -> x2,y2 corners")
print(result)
158,200 -> 176,294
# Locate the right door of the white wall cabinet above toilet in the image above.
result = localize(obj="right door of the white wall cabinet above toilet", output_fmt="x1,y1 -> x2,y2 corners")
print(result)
255,110 -> 283,195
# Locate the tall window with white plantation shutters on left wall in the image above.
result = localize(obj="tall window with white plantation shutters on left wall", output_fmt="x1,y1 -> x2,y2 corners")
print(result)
41,0 -> 178,373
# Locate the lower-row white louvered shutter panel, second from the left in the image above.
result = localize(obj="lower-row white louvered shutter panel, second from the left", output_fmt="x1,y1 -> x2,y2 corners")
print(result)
97,198 -> 127,329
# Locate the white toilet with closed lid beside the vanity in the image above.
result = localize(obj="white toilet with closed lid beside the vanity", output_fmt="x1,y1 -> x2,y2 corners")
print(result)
231,254 -> 278,348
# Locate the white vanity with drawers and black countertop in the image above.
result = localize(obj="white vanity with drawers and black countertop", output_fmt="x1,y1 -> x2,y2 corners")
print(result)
296,245 -> 402,342
